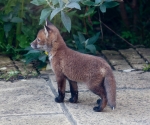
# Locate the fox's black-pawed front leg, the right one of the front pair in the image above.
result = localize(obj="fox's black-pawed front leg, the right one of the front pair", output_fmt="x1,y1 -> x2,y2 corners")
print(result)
68,79 -> 78,103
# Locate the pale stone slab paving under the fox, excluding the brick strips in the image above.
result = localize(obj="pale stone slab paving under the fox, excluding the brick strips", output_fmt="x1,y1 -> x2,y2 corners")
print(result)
0,71 -> 150,125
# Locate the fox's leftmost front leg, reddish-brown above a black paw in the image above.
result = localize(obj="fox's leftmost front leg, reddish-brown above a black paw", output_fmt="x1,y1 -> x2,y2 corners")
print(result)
55,76 -> 66,103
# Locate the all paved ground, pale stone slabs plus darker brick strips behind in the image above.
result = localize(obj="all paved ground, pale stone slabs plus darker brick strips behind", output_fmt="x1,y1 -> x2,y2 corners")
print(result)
0,48 -> 150,125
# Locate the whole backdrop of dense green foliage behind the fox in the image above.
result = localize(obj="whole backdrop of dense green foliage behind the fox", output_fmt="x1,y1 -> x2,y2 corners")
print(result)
0,0 -> 150,70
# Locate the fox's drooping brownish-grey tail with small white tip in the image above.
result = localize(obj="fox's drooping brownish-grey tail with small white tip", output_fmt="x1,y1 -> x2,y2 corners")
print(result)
104,72 -> 116,110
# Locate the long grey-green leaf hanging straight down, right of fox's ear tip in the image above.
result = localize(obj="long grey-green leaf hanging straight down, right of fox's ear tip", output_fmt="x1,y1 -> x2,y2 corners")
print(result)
61,11 -> 71,32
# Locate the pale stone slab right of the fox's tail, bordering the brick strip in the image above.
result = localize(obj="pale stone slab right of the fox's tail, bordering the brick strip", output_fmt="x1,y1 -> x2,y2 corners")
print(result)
113,71 -> 150,90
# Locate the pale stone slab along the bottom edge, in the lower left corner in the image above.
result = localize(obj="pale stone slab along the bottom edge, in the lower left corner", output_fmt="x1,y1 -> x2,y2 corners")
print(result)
0,114 -> 71,125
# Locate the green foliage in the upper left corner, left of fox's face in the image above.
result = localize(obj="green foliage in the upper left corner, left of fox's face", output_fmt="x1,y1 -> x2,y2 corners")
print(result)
0,0 -> 39,59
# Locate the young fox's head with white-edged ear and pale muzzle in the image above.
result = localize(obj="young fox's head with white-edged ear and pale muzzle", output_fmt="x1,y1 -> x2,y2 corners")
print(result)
31,21 -> 59,52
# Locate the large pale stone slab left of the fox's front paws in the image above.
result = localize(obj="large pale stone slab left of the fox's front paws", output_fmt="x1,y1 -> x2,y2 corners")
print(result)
0,79 -> 62,117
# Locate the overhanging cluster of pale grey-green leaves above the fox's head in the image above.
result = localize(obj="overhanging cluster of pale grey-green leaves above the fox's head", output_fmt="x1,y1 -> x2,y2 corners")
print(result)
31,0 -> 118,32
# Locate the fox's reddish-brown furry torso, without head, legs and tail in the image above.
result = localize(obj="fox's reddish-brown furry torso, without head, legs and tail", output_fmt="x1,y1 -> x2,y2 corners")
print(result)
51,48 -> 111,82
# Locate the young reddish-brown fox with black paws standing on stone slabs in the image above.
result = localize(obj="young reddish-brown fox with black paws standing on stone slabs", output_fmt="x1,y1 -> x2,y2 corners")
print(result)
31,20 -> 116,112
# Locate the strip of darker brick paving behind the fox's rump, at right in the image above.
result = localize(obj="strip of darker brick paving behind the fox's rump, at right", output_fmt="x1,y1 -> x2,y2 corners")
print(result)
102,48 -> 150,70
